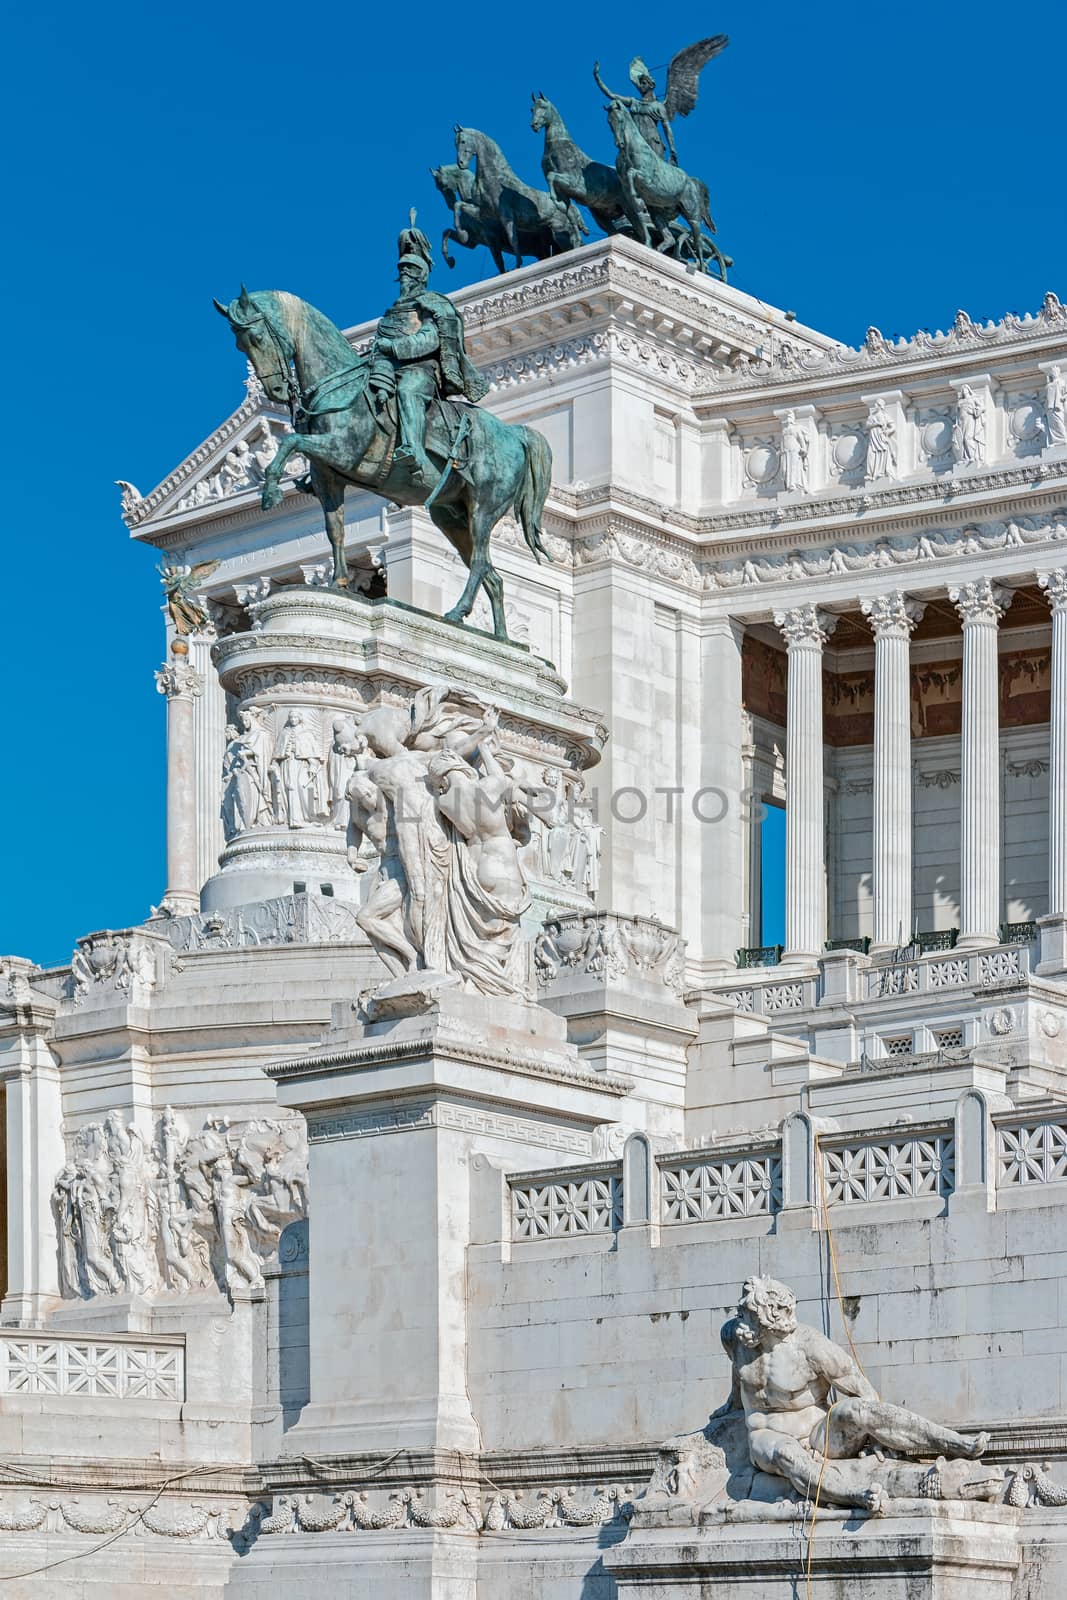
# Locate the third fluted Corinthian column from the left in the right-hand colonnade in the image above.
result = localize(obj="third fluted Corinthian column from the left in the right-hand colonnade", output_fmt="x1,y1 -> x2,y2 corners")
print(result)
949,578 -> 1011,947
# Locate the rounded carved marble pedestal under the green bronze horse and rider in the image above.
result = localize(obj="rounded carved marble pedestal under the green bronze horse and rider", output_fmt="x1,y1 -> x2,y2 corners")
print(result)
199,586 -> 606,928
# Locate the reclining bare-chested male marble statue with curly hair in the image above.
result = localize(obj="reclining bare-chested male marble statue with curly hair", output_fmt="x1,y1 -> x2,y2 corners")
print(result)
715,1277 -> 989,1512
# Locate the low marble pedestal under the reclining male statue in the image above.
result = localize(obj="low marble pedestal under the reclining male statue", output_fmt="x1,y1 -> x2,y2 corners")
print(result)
603,1501 -> 1021,1600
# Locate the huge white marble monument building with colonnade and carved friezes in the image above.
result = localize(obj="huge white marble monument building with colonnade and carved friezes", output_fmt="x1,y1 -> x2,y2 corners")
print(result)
0,240 -> 1067,1600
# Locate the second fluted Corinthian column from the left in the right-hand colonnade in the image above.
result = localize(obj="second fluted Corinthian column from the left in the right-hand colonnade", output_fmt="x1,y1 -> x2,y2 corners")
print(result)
862,592 -> 923,950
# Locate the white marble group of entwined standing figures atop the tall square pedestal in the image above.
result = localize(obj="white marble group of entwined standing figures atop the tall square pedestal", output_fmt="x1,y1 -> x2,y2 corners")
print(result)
349,691 -> 530,994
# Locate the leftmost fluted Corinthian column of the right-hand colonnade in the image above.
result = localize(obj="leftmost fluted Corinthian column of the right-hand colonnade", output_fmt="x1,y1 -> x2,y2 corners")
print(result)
774,605 -> 837,963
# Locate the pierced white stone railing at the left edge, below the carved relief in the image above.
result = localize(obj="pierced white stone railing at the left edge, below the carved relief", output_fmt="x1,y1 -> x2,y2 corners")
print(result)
0,1331 -> 186,1402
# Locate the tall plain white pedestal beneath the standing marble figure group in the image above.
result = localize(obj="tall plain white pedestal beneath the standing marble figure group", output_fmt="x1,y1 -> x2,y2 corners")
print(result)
267,984 -> 629,1459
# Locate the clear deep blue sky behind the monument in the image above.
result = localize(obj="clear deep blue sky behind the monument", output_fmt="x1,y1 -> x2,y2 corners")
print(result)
0,0 -> 1067,962
